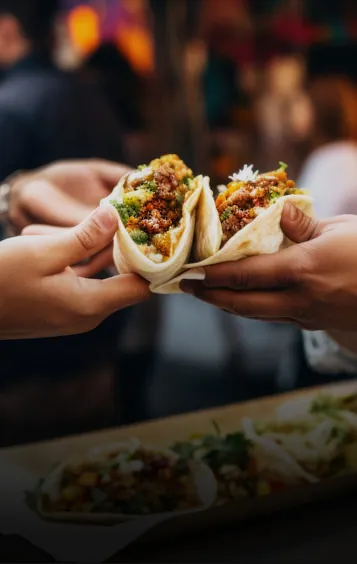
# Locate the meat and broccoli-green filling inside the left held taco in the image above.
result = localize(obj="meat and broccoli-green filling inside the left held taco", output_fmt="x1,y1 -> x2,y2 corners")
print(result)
110,155 -> 197,263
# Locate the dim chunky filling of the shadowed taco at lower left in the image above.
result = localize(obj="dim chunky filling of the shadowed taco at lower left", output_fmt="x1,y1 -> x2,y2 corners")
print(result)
41,446 -> 202,515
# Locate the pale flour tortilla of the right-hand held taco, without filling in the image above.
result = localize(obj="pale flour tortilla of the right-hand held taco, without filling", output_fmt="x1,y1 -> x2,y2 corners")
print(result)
155,188 -> 314,294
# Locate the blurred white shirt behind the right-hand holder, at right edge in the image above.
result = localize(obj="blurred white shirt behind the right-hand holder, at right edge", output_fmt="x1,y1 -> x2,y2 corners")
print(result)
298,141 -> 357,374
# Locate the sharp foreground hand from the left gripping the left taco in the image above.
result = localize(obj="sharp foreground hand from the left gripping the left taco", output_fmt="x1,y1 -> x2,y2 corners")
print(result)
0,206 -> 150,339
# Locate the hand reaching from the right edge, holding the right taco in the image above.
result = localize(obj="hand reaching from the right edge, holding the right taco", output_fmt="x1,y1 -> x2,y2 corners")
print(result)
181,204 -> 357,332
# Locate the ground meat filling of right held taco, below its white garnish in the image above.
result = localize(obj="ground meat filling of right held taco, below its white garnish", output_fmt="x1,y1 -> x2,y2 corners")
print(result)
217,176 -> 295,243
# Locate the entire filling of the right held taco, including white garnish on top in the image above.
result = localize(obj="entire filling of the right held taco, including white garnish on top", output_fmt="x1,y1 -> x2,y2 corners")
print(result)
216,163 -> 305,245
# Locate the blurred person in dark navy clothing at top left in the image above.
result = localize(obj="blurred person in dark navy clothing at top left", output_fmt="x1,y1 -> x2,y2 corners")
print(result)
0,0 -> 123,181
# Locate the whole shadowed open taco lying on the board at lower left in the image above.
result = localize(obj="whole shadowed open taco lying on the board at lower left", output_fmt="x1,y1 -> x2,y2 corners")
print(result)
37,439 -> 216,524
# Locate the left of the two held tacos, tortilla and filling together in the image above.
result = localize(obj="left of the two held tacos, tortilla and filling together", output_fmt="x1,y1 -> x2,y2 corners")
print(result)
103,155 -> 203,291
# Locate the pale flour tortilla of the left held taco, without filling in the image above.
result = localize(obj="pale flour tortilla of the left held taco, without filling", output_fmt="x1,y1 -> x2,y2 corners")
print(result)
103,173 -> 204,292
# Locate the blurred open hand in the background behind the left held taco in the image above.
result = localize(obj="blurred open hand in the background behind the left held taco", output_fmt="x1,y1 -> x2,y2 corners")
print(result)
9,160 -> 130,234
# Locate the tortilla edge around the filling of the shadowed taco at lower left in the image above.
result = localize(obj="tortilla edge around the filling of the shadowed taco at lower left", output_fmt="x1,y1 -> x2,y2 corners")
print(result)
37,438 -> 218,525
